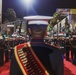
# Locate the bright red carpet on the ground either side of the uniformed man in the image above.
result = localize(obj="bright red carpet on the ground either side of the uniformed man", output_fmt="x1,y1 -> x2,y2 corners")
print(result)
0,59 -> 76,75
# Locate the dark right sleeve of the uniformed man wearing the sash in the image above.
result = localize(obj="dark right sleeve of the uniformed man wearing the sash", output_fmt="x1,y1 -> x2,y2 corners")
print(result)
49,50 -> 64,75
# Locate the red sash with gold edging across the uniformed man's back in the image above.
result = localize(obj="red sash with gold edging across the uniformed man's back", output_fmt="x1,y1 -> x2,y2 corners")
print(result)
14,42 -> 49,75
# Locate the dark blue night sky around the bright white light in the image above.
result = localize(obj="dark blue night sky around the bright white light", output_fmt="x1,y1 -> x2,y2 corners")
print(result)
2,0 -> 76,18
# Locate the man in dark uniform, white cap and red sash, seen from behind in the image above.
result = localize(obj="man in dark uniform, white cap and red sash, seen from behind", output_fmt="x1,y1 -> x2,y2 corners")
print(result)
10,16 -> 64,75
